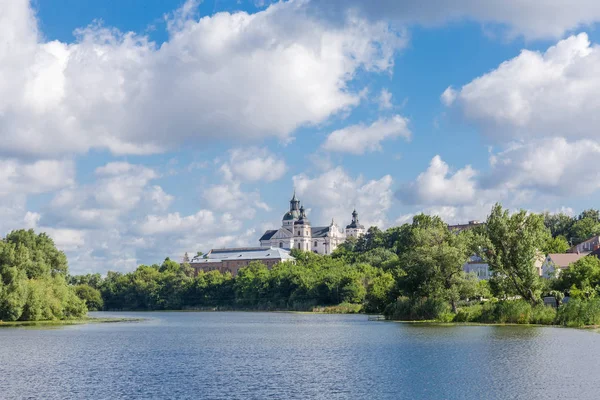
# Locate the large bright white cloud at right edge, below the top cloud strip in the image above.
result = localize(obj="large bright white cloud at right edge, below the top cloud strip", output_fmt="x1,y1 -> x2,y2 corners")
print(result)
445,33 -> 600,142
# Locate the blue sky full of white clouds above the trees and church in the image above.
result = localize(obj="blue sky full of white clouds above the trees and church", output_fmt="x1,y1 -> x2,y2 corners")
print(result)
0,0 -> 600,274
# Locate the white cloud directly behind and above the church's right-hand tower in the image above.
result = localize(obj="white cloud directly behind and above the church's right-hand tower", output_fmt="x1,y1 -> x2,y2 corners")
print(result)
293,167 -> 393,227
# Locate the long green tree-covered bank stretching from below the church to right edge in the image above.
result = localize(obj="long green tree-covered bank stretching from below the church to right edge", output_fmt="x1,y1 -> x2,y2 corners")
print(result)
59,205 -> 600,326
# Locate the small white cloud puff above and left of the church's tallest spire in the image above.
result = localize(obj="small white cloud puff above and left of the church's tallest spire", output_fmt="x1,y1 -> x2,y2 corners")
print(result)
221,147 -> 287,182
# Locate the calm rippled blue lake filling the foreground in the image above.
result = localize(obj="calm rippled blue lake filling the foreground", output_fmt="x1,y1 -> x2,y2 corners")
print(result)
0,312 -> 600,400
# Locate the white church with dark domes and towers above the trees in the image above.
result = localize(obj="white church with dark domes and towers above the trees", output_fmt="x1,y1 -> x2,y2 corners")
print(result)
260,193 -> 365,254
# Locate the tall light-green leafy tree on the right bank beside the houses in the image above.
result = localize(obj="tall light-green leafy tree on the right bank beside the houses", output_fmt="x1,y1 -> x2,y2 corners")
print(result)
482,204 -> 550,304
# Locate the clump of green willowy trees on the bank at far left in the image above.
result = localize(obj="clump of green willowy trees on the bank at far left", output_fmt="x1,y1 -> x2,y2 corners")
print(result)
0,230 -> 87,321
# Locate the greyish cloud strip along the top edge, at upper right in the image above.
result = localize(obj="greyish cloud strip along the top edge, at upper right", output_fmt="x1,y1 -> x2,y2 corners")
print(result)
313,0 -> 600,39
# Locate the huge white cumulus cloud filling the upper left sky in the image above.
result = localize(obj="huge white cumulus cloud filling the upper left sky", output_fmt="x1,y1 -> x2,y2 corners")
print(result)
0,0 -> 404,156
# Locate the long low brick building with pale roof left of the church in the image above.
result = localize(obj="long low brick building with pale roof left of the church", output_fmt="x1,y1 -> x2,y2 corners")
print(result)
185,247 -> 295,276
